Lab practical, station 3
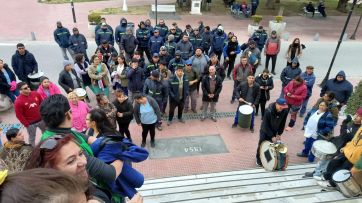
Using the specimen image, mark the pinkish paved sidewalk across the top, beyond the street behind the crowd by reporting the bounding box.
[0,0,362,42]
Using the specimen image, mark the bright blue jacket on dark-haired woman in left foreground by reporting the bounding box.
[90,135,148,199]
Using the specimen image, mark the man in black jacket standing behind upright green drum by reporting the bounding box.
[232,74,260,133]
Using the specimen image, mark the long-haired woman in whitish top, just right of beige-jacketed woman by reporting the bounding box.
[111,54,129,95]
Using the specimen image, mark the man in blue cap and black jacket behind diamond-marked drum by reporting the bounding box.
[256,98,288,166]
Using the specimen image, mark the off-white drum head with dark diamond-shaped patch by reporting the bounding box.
[260,141,276,171]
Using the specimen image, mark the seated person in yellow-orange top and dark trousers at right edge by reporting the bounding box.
[317,127,362,187]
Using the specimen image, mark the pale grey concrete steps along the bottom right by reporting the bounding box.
[139,164,362,203]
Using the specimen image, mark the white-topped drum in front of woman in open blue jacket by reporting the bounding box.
[311,140,337,160]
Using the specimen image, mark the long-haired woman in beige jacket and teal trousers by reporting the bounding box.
[88,55,110,97]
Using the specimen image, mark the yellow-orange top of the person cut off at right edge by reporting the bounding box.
[343,127,362,164]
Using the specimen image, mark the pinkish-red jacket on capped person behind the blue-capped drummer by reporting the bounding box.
[283,80,307,106]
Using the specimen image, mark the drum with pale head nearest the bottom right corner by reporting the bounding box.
[332,169,362,197]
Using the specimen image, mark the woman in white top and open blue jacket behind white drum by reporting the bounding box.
[297,101,335,162]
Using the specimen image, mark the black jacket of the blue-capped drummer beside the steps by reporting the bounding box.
[260,102,288,139]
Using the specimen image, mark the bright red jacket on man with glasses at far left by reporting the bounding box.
[14,91,43,127]
